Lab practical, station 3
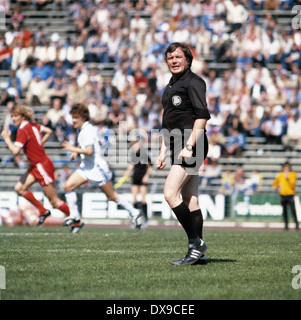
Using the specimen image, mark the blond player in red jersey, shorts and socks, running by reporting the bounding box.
[1,105,70,226]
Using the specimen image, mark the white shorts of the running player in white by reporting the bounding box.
[77,161,112,187]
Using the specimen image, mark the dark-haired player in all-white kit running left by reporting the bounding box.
[63,104,143,233]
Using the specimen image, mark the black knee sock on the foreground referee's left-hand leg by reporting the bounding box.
[172,202,200,245]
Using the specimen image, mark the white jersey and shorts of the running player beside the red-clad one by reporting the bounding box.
[77,121,112,186]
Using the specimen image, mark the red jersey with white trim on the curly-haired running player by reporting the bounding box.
[15,121,48,166]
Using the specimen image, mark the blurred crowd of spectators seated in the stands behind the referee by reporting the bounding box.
[0,0,301,168]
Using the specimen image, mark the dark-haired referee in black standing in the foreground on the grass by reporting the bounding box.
[156,42,210,265]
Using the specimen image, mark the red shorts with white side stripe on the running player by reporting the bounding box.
[28,158,55,187]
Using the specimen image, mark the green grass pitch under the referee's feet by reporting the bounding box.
[0,227,301,300]
